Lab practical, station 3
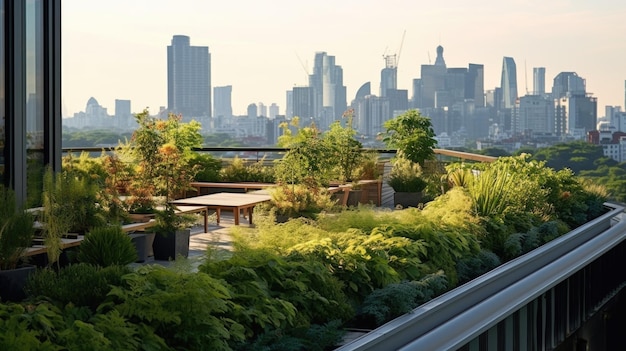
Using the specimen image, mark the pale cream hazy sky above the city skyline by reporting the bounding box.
[61,0,626,117]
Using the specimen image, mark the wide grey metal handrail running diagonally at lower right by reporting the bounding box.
[336,203,626,351]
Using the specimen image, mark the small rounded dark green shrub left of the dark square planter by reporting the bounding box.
[77,226,137,267]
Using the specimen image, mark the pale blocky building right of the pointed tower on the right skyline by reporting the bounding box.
[511,95,555,136]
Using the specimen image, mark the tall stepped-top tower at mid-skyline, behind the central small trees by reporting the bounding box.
[309,52,348,130]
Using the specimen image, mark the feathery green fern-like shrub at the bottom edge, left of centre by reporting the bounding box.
[99,265,243,350]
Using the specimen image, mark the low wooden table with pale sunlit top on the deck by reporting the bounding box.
[171,193,270,225]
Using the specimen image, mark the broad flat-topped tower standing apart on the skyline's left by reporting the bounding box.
[167,35,212,119]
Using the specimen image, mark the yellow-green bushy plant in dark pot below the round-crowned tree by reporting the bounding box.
[387,155,428,208]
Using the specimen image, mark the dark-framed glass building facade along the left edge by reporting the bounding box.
[0,0,62,206]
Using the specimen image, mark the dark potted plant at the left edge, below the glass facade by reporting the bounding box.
[0,185,36,301]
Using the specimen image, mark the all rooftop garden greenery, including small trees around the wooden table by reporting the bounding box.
[0,111,608,350]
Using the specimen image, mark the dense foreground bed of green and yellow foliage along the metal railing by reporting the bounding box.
[0,150,606,351]
